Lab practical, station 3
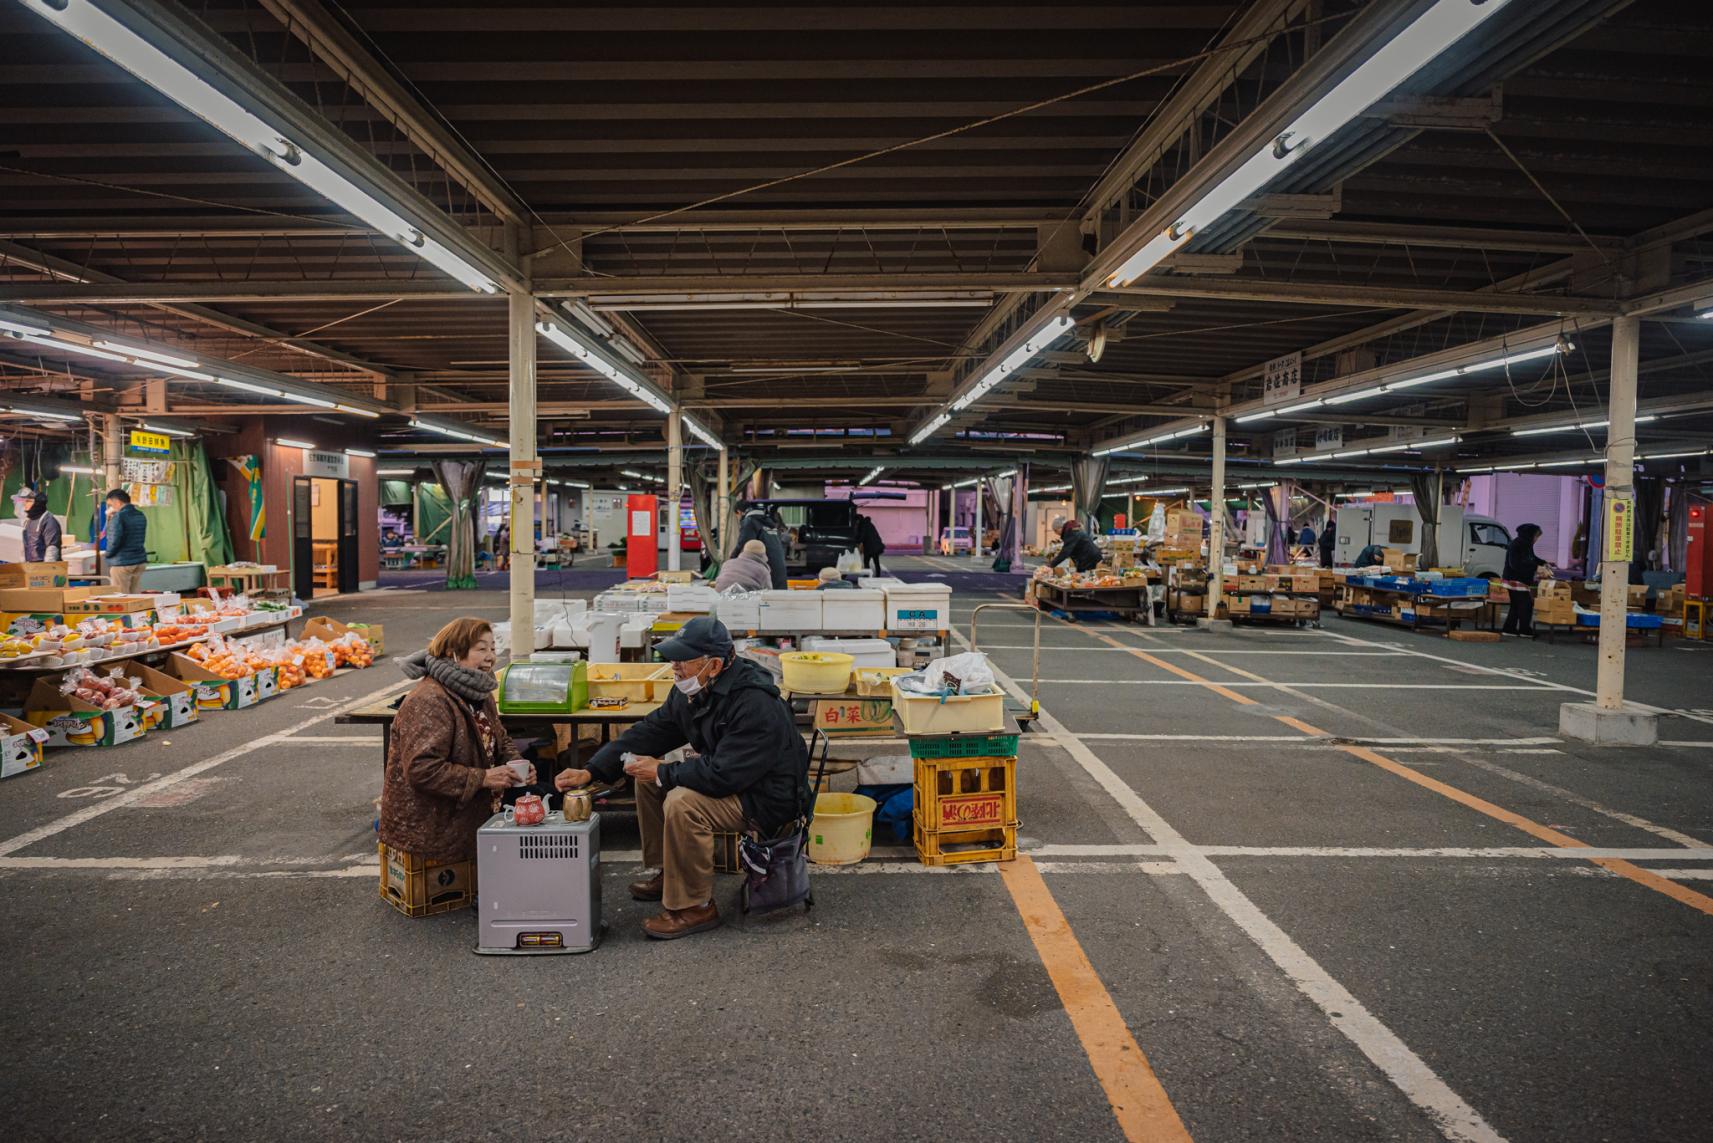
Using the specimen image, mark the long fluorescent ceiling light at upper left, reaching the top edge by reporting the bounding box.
[26,0,498,293]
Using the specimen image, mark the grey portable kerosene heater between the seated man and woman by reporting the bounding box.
[476,811,606,956]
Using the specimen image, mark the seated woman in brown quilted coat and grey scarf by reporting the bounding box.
[380,619,534,862]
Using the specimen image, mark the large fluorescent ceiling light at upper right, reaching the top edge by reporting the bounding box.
[1107,0,1507,286]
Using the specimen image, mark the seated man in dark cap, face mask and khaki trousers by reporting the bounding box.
[555,617,809,941]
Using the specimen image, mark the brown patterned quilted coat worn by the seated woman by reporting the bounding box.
[380,679,517,862]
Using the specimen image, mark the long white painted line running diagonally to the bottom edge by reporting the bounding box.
[954,632,1504,1143]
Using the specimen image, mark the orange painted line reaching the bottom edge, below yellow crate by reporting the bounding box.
[999,855,1191,1143]
